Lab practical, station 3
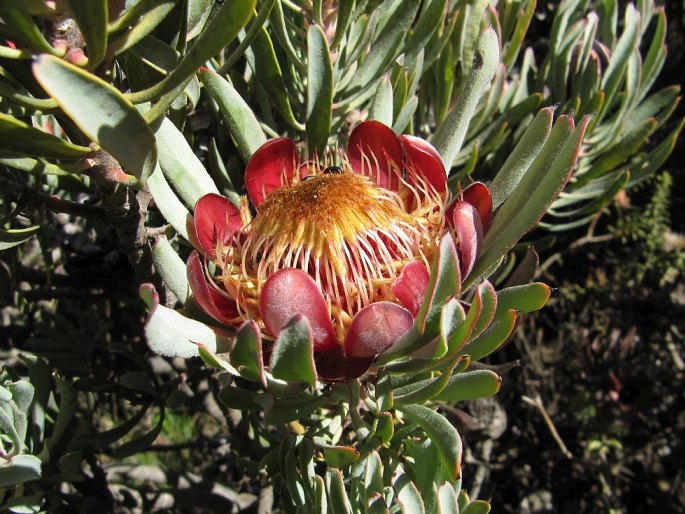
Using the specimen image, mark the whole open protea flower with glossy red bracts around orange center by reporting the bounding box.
[188,121,491,380]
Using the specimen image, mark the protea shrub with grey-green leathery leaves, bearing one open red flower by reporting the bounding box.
[0,0,677,513]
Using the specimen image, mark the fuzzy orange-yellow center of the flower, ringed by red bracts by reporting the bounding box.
[222,169,442,340]
